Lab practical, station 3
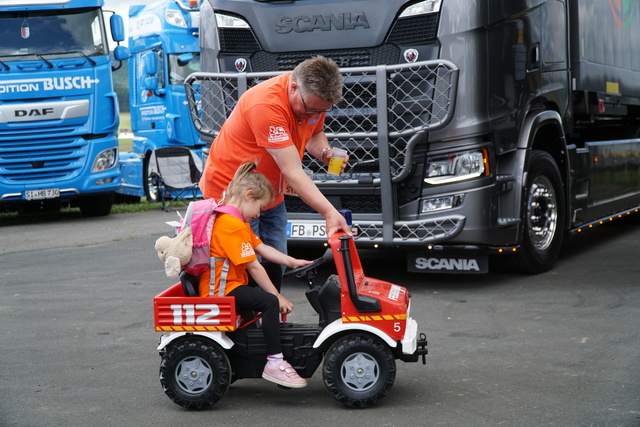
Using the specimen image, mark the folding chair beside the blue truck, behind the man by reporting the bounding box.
[149,146,202,211]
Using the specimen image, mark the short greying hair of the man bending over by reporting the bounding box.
[292,56,342,104]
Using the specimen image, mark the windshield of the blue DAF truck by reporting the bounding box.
[0,8,107,61]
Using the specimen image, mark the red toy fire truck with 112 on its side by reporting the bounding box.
[154,232,427,409]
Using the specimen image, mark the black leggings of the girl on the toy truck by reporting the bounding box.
[227,286,282,356]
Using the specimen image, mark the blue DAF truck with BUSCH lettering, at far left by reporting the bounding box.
[0,0,128,216]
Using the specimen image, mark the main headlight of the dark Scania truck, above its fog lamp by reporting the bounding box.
[424,148,489,184]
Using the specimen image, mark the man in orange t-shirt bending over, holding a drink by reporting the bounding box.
[200,56,351,253]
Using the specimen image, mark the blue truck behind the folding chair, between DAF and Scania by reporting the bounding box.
[119,0,204,201]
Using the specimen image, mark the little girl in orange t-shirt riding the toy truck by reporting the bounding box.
[198,162,311,388]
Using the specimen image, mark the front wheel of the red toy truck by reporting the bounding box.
[322,334,396,408]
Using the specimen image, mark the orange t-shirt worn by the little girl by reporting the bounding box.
[198,212,262,297]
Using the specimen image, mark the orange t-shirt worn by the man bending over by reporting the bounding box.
[200,73,325,209]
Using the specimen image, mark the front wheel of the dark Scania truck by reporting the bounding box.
[517,150,565,274]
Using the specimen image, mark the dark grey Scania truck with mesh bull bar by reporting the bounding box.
[187,0,640,273]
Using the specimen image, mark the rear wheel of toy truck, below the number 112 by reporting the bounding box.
[160,338,231,409]
